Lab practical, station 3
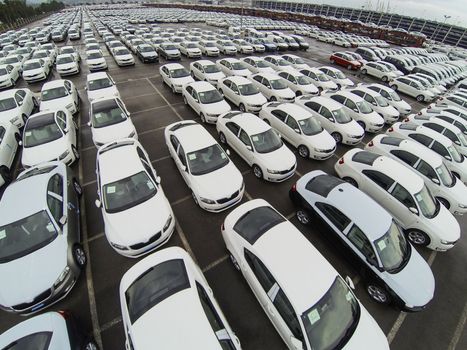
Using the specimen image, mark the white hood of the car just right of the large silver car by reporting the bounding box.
[102,188,173,246]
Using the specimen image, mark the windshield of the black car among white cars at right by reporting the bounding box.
[374,221,410,272]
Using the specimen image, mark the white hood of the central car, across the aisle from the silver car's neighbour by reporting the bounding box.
[192,161,243,200]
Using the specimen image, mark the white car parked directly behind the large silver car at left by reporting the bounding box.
[21,109,79,168]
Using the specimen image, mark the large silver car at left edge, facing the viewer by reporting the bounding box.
[0,161,86,314]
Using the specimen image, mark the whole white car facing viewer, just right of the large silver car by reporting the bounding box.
[96,138,175,258]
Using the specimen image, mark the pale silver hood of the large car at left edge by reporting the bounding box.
[0,234,68,306]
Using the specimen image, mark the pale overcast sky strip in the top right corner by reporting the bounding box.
[282,0,467,27]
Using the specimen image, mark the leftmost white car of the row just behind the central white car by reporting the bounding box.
[182,81,232,124]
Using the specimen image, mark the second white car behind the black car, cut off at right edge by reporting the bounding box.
[365,134,467,215]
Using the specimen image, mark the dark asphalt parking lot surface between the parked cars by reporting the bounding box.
[0,19,467,350]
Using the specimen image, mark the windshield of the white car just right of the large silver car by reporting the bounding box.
[103,171,157,213]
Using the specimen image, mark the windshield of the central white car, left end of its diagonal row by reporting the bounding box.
[187,143,229,176]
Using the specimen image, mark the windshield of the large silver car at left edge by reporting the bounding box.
[0,210,57,263]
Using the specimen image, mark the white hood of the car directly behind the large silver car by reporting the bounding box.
[21,136,67,166]
